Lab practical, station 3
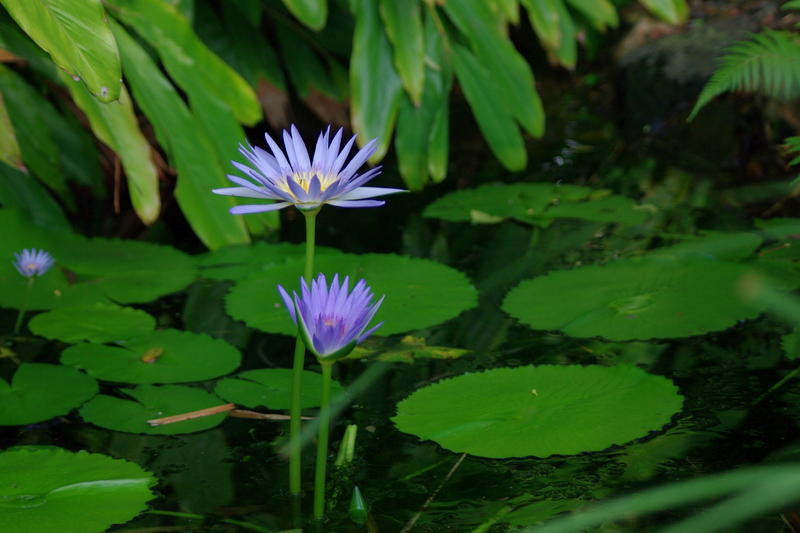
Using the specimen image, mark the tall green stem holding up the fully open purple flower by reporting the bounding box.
[289,210,319,494]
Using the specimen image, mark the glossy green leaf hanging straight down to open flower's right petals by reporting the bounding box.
[350,0,403,163]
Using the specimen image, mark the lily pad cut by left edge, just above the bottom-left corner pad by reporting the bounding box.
[0,363,98,424]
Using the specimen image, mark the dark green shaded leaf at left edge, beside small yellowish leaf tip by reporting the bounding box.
[0,65,65,200]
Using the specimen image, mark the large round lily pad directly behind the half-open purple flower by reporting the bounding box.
[226,254,477,335]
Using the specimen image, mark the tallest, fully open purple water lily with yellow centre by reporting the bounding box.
[214,126,405,215]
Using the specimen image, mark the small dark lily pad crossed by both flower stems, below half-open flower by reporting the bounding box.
[214,368,344,409]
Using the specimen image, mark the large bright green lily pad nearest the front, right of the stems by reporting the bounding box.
[392,365,683,458]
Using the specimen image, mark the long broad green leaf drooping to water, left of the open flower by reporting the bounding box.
[112,18,249,249]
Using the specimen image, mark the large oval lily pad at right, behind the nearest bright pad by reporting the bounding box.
[503,256,759,340]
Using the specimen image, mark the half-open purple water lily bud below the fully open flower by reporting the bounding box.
[278,274,384,361]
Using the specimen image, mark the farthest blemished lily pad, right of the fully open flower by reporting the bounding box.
[423,183,647,227]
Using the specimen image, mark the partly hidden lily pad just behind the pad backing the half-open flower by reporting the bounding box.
[198,242,342,280]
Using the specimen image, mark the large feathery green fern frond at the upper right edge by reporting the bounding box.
[688,30,800,120]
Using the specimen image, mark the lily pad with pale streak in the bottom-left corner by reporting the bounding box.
[0,447,156,533]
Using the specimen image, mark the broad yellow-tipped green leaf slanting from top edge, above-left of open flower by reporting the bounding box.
[107,0,261,125]
